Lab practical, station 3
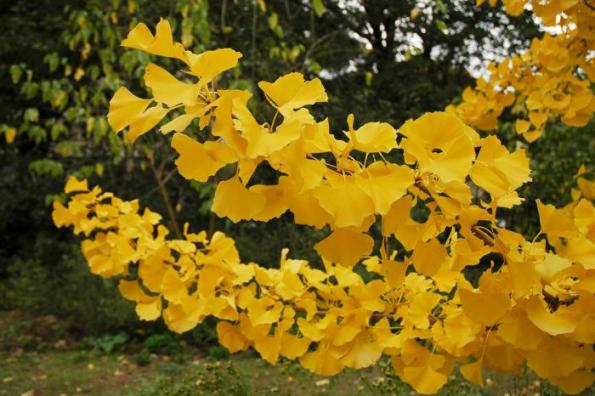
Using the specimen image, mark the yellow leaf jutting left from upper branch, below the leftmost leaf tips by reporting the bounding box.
[171,133,237,182]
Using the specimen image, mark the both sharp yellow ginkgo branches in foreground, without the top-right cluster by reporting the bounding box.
[53,3,595,394]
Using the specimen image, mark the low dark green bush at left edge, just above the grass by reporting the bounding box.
[0,243,139,335]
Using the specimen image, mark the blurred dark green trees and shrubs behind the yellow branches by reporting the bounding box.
[0,0,595,394]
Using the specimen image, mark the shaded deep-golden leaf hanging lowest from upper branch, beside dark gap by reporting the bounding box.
[314,229,374,267]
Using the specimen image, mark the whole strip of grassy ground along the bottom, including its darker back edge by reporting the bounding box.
[0,313,593,396]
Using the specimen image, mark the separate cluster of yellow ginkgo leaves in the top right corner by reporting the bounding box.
[450,0,595,142]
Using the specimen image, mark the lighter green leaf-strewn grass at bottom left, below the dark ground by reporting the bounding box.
[0,350,379,396]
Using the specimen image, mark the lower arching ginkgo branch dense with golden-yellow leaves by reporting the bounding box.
[53,169,595,394]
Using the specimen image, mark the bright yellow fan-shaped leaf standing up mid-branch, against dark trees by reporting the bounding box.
[258,73,328,115]
